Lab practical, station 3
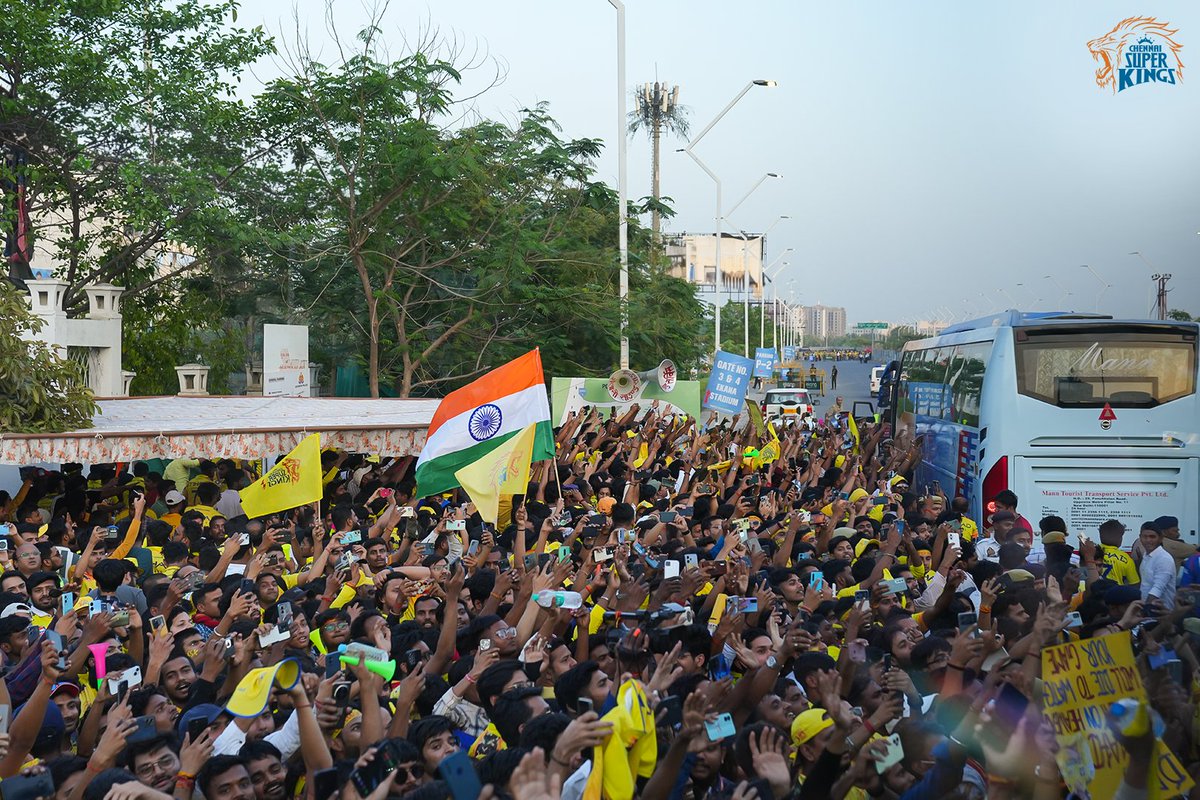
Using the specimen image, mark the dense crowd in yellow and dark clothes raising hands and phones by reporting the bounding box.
[0,404,1200,800]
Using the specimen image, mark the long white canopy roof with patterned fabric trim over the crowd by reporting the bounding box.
[0,397,440,464]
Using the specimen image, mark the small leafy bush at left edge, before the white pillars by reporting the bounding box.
[0,281,96,433]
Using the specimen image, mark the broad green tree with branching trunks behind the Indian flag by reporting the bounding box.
[259,26,700,397]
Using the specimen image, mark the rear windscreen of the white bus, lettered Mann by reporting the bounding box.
[1015,326,1196,408]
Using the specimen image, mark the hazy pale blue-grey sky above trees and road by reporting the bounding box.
[248,0,1200,321]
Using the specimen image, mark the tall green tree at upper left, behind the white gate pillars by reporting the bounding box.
[0,0,272,390]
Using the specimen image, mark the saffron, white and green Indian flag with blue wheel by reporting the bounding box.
[416,350,554,497]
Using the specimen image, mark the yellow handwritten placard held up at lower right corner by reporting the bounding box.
[1042,631,1193,800]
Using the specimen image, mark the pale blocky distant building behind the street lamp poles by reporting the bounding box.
[662,233,763,300]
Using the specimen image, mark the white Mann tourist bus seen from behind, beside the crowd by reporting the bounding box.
[892,311,1200,547]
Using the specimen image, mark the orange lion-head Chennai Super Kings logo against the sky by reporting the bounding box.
[1087,17,1183,94]
